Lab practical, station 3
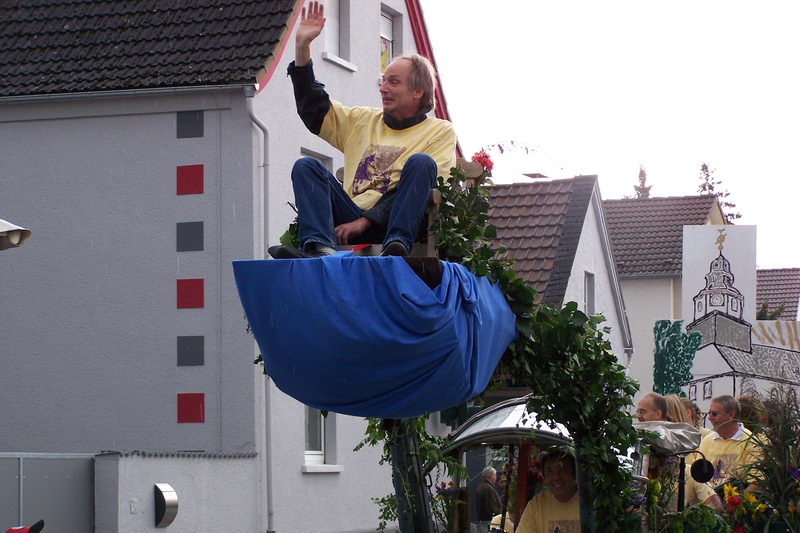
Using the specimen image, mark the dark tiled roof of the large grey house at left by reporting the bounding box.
[0,0,296,96]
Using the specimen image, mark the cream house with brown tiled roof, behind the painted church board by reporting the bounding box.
[603,195,725,400]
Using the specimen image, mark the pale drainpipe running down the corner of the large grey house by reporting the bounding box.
[244,86,275,533]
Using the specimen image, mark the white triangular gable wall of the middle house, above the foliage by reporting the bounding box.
[564,193,635,365]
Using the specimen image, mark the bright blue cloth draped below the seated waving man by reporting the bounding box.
[233,252,516,418]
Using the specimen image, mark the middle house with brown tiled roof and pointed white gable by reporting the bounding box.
[489,176,634,365]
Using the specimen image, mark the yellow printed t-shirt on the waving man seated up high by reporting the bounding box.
[319,100,456,210]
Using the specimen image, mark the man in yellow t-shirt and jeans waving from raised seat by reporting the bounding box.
[269,1,456,259]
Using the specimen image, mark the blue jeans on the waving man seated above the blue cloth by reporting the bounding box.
[292,154,437,250]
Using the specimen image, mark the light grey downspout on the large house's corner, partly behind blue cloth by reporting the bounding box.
[244,87,275,533]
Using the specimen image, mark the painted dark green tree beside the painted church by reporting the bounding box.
[653,320,703,395]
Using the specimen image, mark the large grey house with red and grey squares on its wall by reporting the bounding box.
[0,0,447,533]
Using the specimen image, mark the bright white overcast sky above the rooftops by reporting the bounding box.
[422,0,800,268]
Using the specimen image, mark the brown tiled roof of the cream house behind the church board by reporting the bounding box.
[603,195,716,278]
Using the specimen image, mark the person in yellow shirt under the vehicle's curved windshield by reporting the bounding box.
[517,450,581,533]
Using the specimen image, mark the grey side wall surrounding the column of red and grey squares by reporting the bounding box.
[0,91,255,452]
